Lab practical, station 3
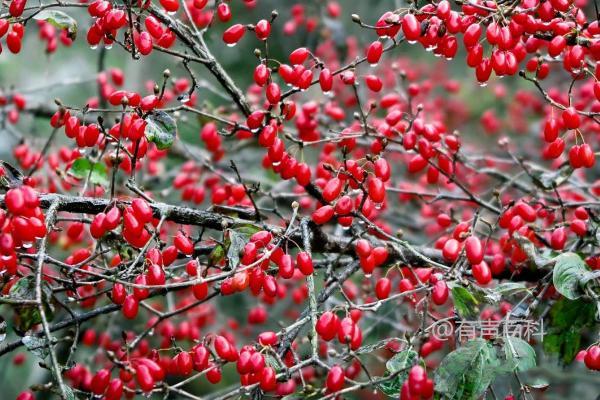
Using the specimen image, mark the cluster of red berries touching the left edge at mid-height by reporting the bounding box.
[0,185,46,275]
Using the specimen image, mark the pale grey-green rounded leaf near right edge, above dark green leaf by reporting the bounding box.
[552,253,589,300]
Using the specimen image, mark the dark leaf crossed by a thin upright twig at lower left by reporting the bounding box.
[9,276,54,332]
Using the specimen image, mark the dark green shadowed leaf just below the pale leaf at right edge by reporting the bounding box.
[544,297,596,364]
